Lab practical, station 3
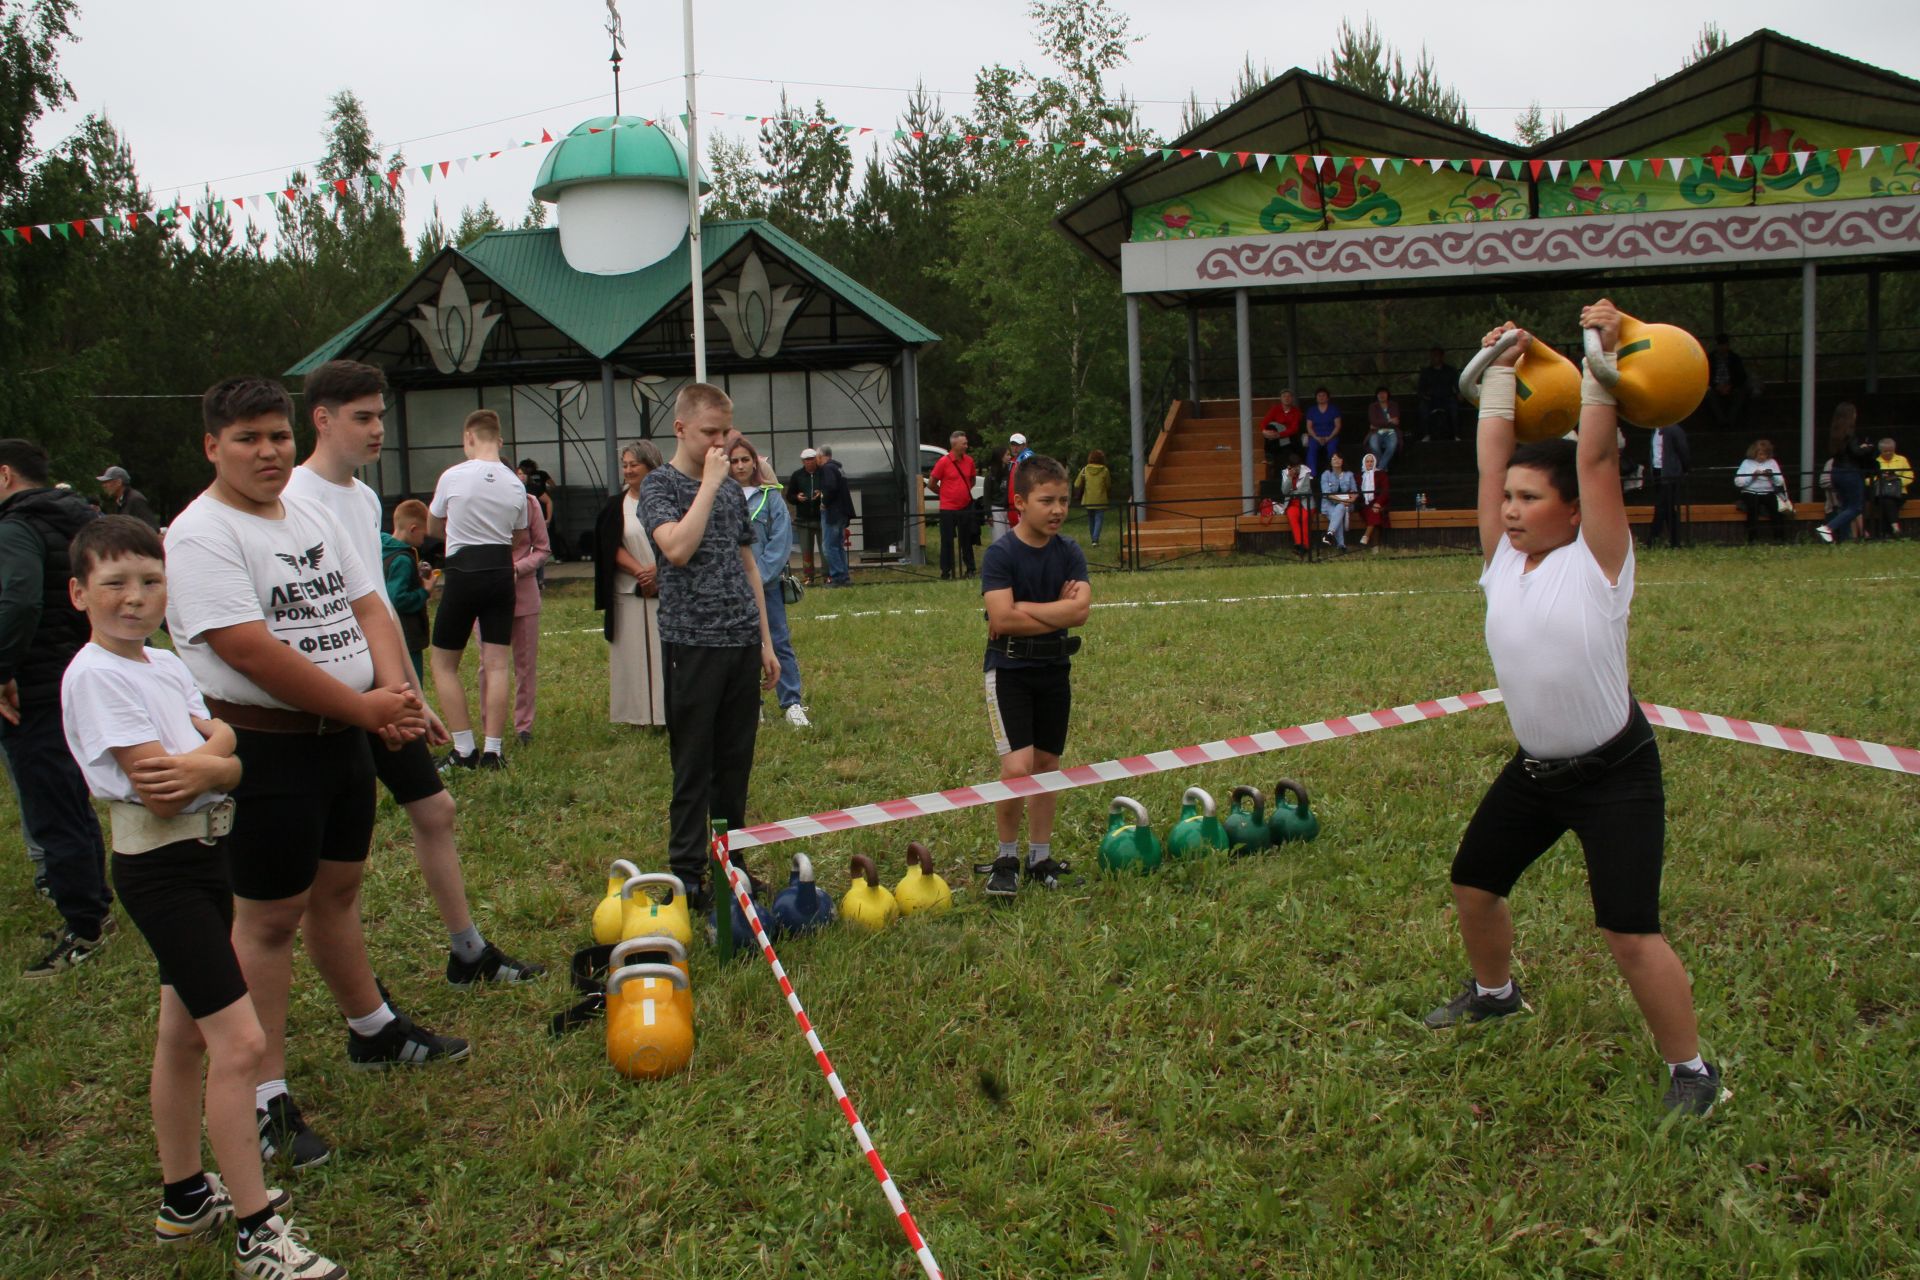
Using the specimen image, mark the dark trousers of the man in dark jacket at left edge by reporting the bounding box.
[0,697,113,938]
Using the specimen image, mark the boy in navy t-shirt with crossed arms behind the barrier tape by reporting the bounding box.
[979,455,1092,898]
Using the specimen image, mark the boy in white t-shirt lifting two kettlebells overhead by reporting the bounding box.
[1427,299,1720,1115]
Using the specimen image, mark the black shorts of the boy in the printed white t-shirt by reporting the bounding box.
[227,729,384,902]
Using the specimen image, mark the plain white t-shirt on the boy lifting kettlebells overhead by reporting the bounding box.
[1480,535,1634,760]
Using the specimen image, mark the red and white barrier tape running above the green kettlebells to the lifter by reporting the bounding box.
[732,689,1500,848]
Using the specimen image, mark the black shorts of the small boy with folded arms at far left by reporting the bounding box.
[113,841,246,1017]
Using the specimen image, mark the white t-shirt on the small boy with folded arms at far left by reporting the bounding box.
[60,645,227,814]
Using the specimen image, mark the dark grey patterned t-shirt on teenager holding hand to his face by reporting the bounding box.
[639,462,760,649]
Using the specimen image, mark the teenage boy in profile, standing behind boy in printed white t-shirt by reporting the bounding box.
[286,361,545,986]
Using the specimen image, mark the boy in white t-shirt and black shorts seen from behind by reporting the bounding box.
[426,409,526,770]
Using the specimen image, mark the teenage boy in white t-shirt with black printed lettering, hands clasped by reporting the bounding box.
[167,378,467,1169]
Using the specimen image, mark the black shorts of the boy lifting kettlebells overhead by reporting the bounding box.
[1453,704,1667,933]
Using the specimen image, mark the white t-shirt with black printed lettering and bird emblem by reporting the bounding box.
[167,493,384,710]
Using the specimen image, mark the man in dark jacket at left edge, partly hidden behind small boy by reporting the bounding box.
[0,439,113,979]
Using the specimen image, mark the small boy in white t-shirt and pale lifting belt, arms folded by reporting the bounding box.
[61,516,346,1280]
